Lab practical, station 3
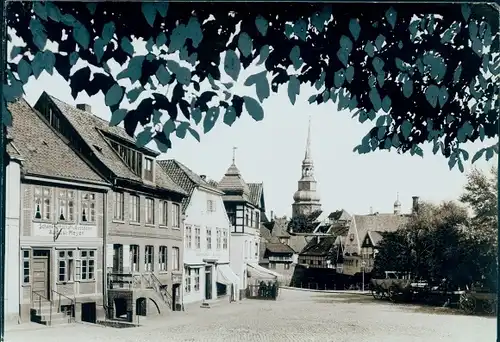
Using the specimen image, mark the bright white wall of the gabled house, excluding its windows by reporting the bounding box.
[183,188,231,304]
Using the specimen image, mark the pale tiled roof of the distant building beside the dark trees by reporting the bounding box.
[345,214,408,254]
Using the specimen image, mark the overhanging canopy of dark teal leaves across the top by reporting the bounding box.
[4,2,500,170]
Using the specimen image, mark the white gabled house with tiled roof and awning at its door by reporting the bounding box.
[159,160,240,304]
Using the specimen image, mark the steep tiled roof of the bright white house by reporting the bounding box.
[157,159,219,212]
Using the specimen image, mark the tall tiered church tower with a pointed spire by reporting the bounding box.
[292,117,321,217]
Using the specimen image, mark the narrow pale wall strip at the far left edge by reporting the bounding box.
[4,160,21,324]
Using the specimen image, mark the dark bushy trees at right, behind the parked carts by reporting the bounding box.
[374,202,497,288]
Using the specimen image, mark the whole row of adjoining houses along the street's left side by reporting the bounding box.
[4,93,280,324]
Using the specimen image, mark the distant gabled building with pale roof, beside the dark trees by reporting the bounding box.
[343,197,412,275]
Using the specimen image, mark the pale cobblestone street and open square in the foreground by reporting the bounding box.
[6,290,496,342]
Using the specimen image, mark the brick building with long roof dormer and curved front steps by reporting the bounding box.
[35,93,186,321]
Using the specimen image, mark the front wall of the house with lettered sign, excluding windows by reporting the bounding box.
[17,181,104,321]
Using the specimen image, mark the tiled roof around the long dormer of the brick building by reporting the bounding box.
[39,93,186,195]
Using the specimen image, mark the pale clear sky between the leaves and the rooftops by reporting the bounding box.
[8,31,497,216]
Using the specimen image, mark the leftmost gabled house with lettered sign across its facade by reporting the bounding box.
[5,99,111,325]
